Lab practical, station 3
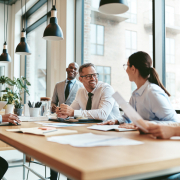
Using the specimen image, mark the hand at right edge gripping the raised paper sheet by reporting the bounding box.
[148,124,176,139]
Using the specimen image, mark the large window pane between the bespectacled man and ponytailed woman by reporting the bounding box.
[82,0,153,101]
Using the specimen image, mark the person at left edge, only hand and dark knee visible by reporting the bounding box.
[0,114,20,179]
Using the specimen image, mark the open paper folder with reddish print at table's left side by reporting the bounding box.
[6,127,77,136]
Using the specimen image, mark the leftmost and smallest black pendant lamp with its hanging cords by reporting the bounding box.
[0,0,11,63]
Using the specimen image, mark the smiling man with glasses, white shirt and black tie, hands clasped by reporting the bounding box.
[56,63,121,121]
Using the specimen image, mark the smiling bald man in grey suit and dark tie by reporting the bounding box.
[51,62,83,112]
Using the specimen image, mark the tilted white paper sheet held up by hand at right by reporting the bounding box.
[112,92,148,133]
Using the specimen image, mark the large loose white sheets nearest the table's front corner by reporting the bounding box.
[47,133,143,147]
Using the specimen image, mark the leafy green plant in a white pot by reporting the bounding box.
[0,76,31,114]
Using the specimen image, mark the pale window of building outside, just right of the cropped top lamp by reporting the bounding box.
[126,0,137,24]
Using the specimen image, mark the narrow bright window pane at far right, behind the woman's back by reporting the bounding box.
[165,0,180,110]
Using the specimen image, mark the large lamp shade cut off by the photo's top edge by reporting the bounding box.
[99,0,129,14]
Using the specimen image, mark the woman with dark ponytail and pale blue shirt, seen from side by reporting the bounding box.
[100,51,178,128]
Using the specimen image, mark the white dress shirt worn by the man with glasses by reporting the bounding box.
[71,81,121,121]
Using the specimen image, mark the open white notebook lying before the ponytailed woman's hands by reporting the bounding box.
[87,125,135,131]
